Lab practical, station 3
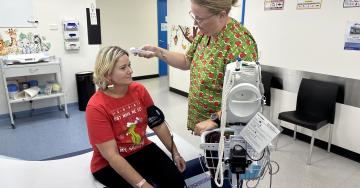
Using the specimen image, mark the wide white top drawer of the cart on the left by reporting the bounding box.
[4,64,60,77]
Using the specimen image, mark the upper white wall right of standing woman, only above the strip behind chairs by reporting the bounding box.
[245,0,360,79]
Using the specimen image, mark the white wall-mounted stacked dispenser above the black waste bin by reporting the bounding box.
[63,20,80,50]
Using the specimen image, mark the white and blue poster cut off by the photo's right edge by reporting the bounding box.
[344,21,360,50]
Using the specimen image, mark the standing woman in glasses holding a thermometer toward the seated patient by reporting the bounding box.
[139,0,258,135]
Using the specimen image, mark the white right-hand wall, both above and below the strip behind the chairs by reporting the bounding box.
[245,1,360,153]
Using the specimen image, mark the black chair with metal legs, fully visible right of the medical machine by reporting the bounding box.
[278,78,339,165]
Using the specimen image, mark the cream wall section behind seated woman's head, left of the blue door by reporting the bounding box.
[97,0,159,76]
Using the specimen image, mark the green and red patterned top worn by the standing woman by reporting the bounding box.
[186,19,258,130]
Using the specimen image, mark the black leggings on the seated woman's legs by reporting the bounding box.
[93,143,185,188]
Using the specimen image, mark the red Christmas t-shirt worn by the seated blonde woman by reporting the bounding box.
[86,82,153,173]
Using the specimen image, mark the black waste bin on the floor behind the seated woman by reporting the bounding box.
[75,71,95,111]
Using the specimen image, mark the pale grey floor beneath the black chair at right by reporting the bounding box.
[253,135,360,188]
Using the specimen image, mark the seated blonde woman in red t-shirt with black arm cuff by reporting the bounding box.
[86,46,186,188]
